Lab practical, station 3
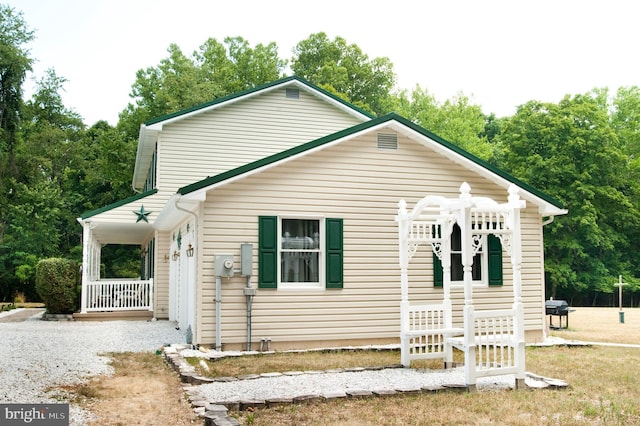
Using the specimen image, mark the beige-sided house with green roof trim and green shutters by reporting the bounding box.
[78,77,566,349]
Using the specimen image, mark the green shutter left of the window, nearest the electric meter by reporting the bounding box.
[258,216,278,288]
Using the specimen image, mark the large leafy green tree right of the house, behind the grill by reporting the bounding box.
[498,92,640,298]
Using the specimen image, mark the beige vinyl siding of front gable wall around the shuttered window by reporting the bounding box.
[200,130,542,349]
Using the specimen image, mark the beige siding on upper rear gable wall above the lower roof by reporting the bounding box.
[157,88,361,191]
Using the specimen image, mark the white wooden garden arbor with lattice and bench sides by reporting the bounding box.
[396,182,526,390]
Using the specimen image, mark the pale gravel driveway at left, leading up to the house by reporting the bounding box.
[0,311,185,424]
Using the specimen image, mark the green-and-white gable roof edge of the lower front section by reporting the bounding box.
[177,113,567,216]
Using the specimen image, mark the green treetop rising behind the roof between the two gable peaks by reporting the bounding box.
[291,32,396,115]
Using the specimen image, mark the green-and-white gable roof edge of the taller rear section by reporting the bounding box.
[132,76,373,189]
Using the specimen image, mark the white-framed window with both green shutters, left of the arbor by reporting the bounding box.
[258,216,343,289]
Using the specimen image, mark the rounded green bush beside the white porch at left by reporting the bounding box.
[36,258,78,314]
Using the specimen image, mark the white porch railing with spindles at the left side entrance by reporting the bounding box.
[83,278,153,312]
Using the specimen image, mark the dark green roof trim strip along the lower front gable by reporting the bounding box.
[178,113,564,209]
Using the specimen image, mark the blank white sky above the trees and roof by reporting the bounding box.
[5,0,640,125]
